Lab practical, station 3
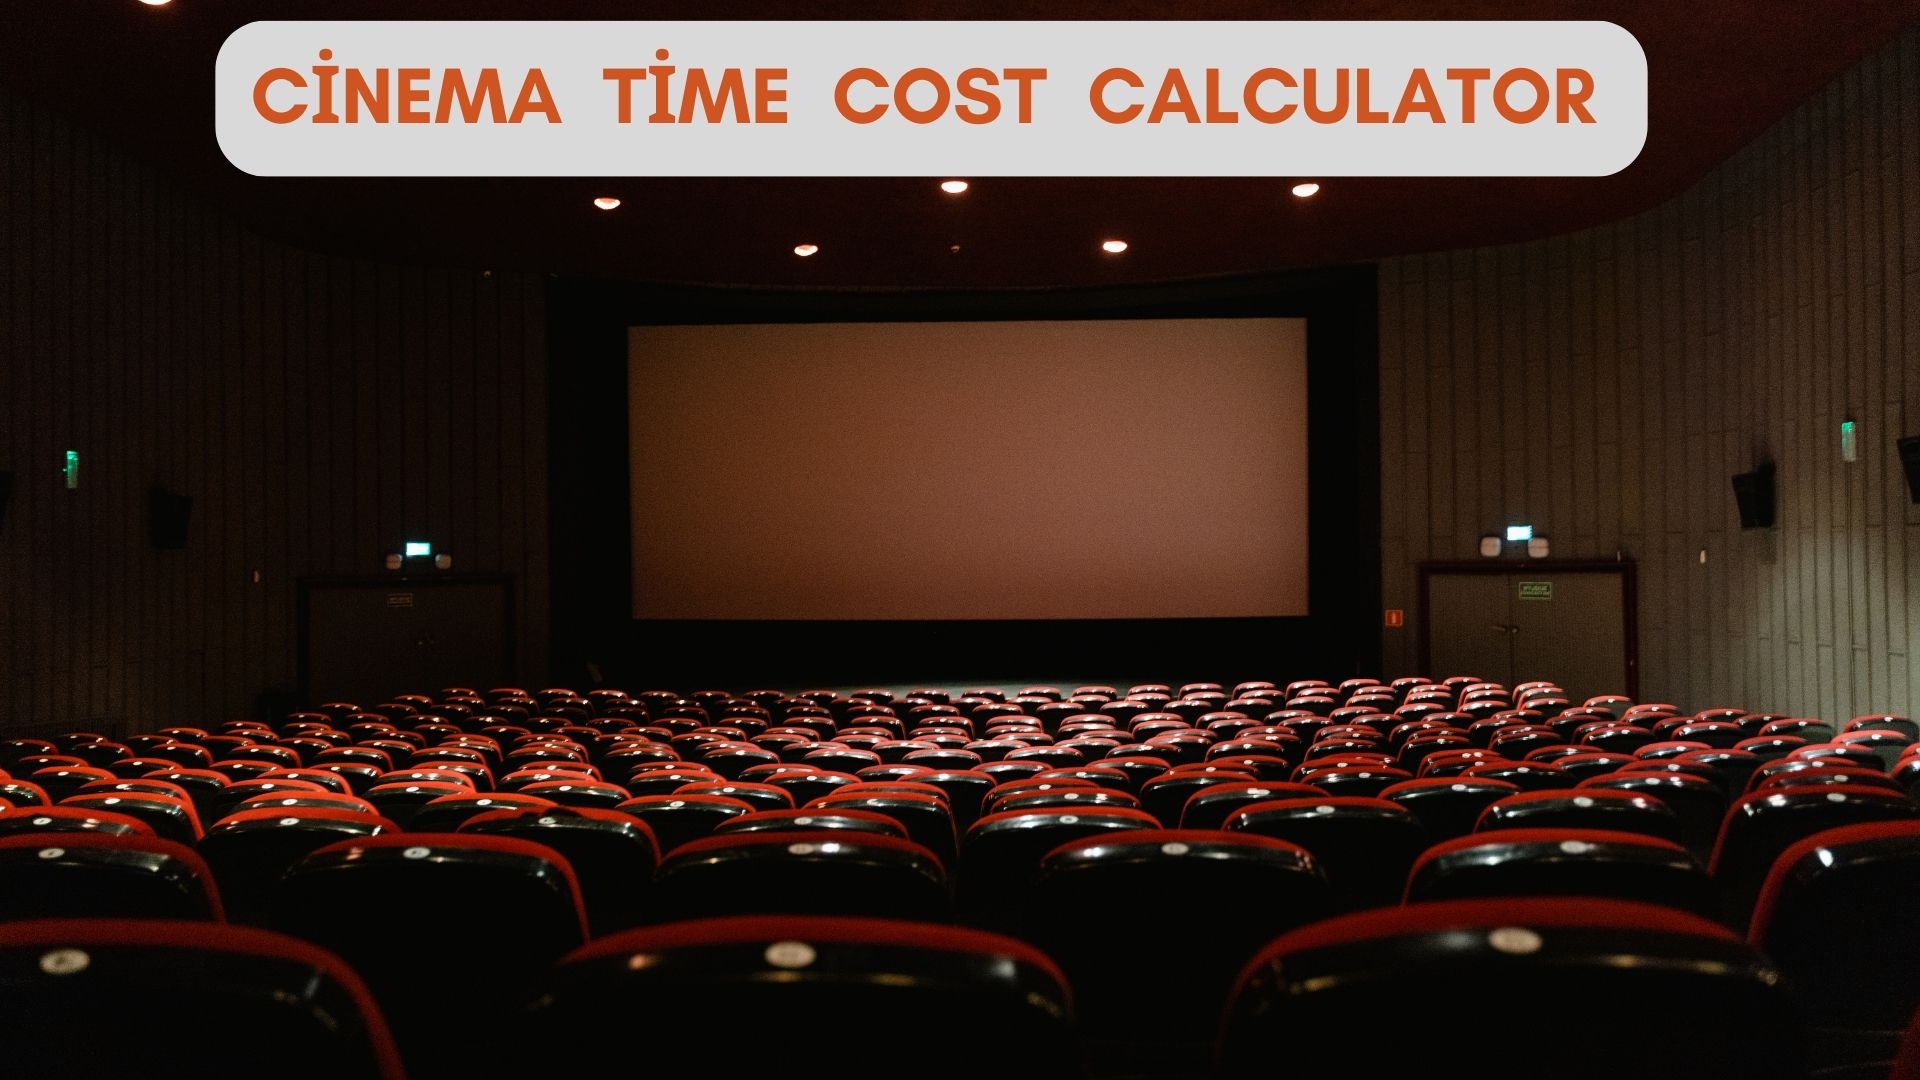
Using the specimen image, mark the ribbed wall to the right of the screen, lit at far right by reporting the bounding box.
[1379,29,1920,719]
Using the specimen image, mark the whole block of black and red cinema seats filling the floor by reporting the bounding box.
[0,678,1920,1078]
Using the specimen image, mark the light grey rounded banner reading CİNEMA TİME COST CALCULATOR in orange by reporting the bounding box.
[215,21,1647,177]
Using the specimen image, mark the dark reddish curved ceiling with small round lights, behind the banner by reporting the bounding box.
[0,0,1920,288]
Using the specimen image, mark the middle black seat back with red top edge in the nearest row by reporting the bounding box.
[516,917,1077,1076]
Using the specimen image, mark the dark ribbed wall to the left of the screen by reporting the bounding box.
[0,94,547,730]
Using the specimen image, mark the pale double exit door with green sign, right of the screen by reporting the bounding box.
[1421,561,1640,703]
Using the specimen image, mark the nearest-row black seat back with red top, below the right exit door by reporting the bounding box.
[1217,897,1805,1080]
